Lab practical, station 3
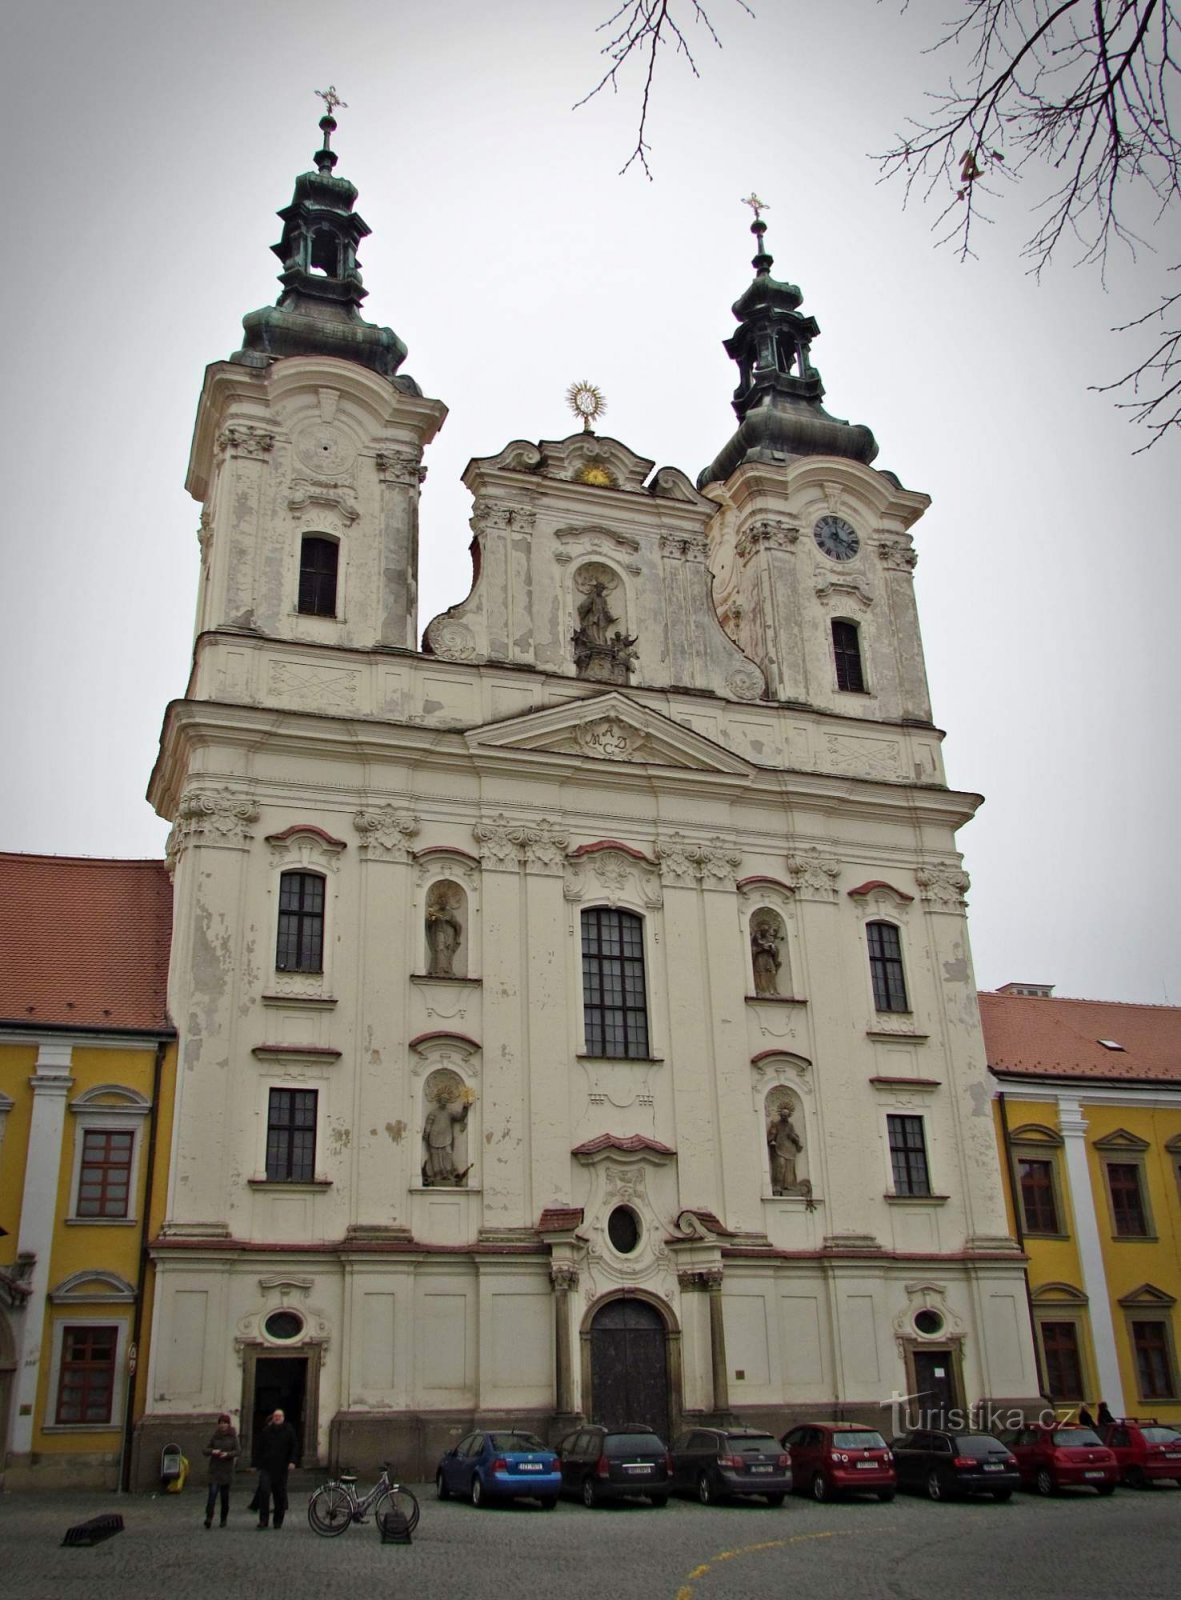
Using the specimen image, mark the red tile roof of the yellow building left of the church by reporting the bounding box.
[0,851,173,1032]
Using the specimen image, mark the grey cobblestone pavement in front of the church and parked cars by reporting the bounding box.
[0,1485,1181,1600]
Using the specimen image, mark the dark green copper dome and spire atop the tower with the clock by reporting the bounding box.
[698,218,877,490]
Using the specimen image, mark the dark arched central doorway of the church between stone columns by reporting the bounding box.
[591,1296,671,1440]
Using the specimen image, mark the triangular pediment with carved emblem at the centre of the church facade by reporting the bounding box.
[466,693,754,778]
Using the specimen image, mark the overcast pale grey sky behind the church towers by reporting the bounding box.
[0,0,1181,1003]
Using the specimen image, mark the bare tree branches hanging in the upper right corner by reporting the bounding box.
[879,0,1181,448]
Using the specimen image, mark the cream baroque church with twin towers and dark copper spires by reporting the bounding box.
[139,117,1037,1482]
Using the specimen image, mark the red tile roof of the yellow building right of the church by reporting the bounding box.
[979,994,1181,1083]
